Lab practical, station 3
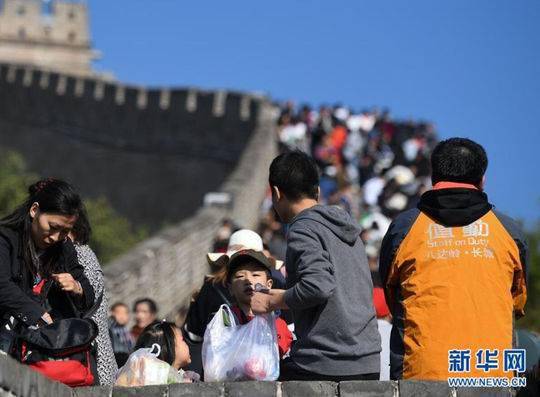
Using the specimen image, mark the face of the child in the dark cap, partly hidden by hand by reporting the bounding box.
[230,262,272,305]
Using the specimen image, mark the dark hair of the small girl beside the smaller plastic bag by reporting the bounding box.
[135,321,176,365]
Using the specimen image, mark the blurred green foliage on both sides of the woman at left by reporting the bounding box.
[0,149,148,263]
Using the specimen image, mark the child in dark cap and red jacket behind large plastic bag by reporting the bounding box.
[227,250,293,358]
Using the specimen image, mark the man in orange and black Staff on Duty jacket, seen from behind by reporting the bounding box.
[379,138,527,381]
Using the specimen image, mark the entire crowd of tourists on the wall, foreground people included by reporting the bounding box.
[0,104,537,392]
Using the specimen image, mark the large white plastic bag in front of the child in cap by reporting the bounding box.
[202,305,279,382]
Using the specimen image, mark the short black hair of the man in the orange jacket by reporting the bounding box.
[431,138,488,185]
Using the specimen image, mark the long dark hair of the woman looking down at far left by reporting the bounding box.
[0,178,84,277]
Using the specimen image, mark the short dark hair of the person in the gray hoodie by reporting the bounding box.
[268,150,319,201]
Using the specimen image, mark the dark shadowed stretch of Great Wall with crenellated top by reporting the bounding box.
[0,63,271,231]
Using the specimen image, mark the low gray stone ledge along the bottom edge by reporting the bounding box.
[0,355,520,397]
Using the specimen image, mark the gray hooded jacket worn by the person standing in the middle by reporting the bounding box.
[285,205,381,376]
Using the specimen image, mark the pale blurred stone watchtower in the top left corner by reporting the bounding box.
[0,0,105,77]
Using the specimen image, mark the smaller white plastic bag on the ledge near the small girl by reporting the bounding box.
[116,344,184,387]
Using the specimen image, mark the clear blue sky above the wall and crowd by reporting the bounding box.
[88,0,540,224]
